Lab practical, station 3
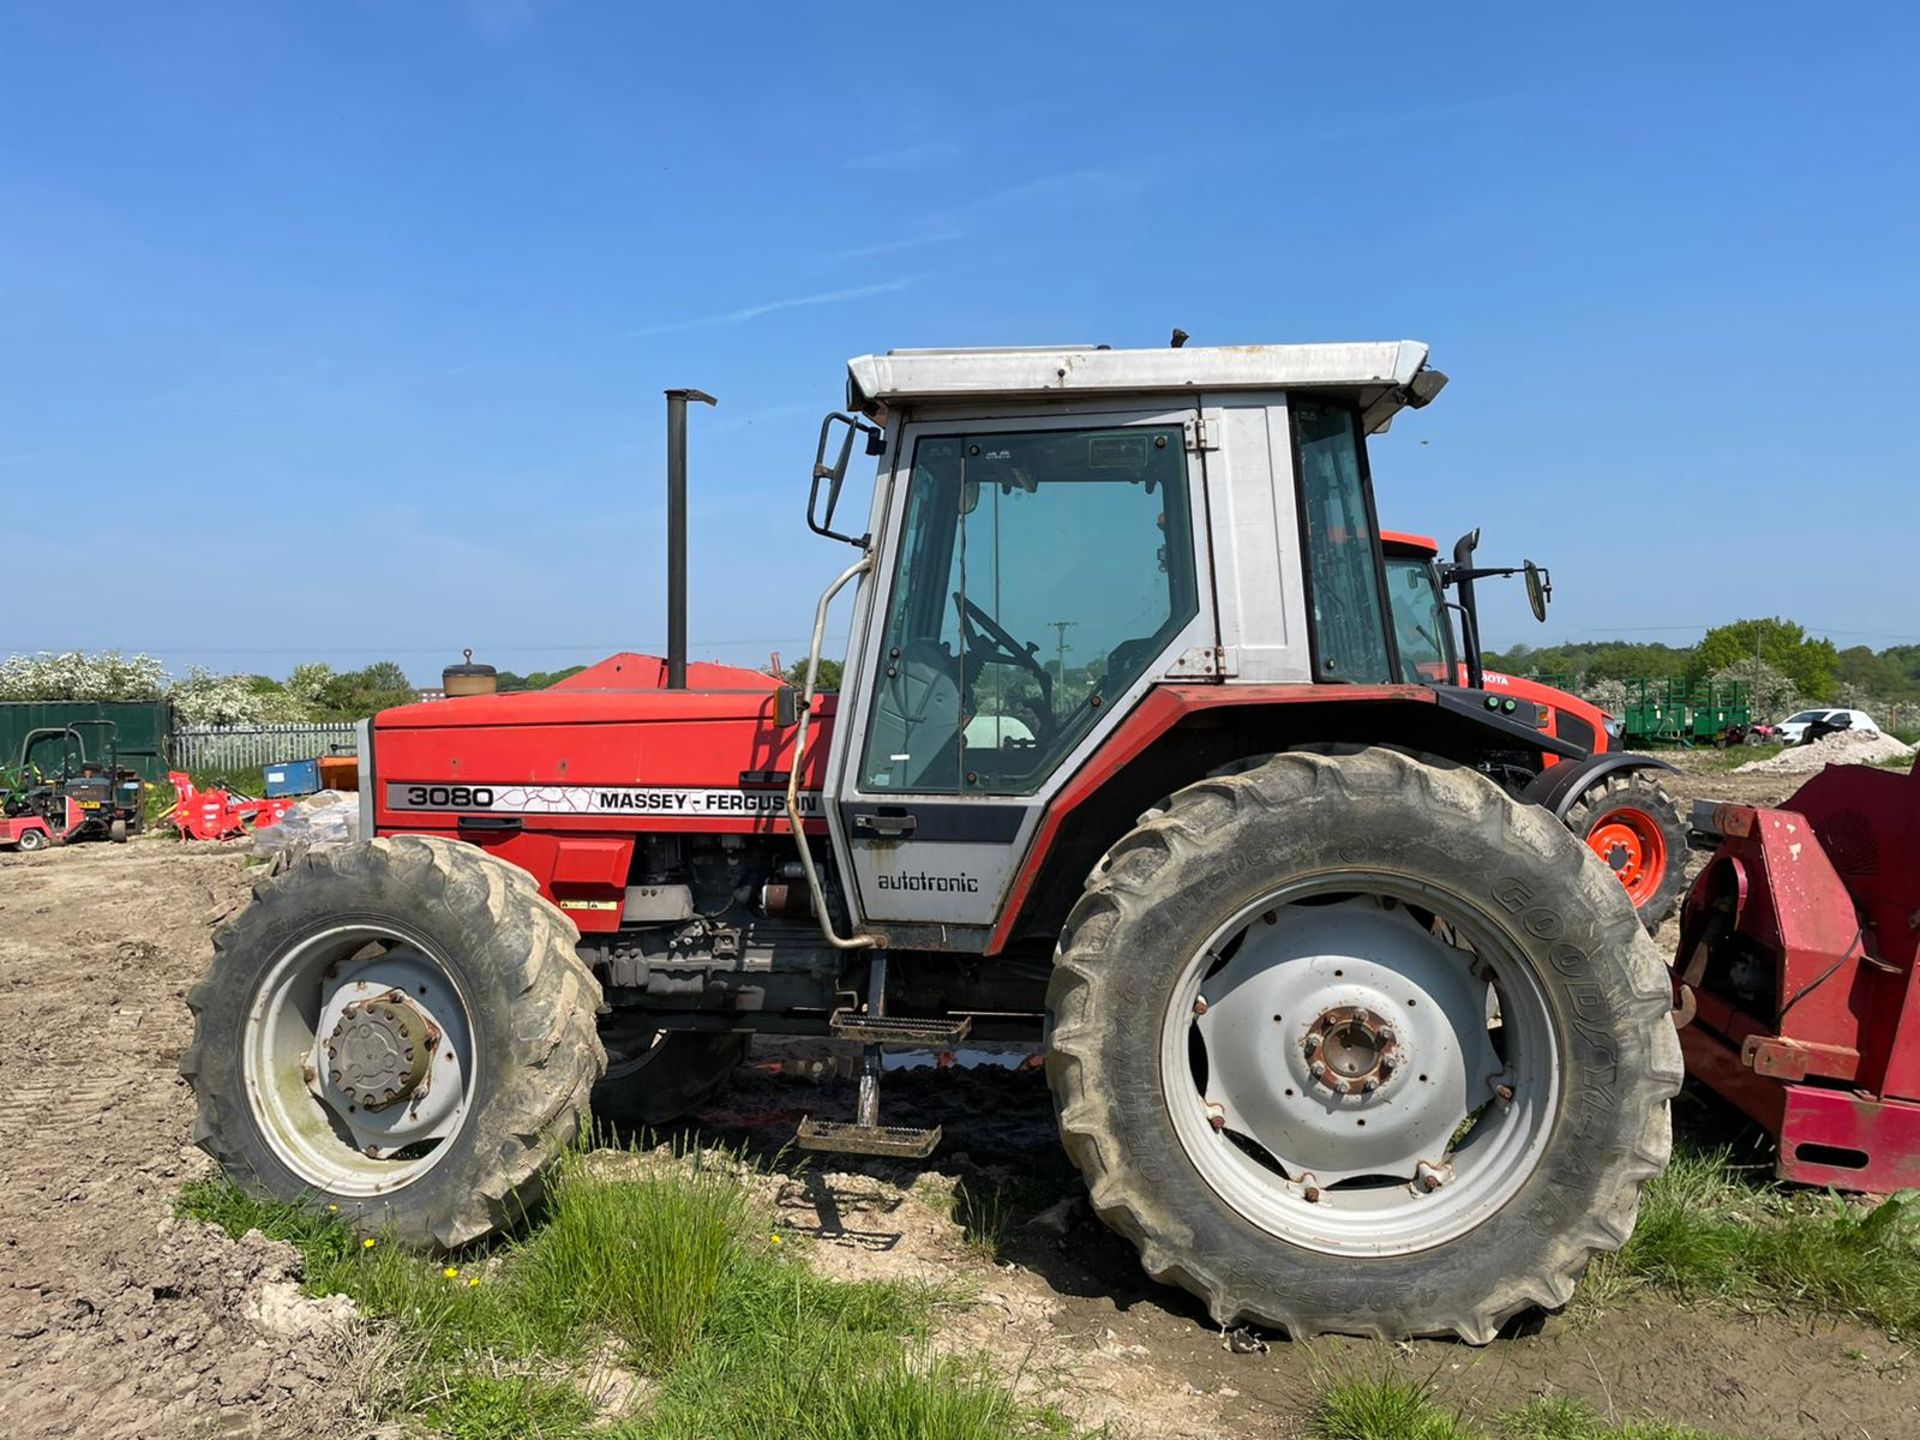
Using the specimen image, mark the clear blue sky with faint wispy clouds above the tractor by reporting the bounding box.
[0,0,1920,680]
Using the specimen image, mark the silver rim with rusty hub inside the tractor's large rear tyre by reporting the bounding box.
[1160,874,1559,1256]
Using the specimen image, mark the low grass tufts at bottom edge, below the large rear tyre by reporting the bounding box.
[1306,1375,1732,1440]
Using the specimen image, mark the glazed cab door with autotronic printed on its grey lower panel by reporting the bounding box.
[833,409,1215,948]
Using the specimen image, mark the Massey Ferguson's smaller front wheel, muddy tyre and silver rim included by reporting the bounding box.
[180,835,605,1248]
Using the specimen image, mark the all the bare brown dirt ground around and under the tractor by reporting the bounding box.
[0,756,1920,1440]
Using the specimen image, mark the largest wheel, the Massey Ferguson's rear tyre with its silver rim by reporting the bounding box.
[1046,749,1682,1344]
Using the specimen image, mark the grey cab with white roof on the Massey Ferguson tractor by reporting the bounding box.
[793,342,1582,950]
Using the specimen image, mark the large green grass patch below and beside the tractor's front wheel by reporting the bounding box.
[179,1152,1066,1440]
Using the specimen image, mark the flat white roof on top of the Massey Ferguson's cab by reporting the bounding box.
[847,340,1444,415]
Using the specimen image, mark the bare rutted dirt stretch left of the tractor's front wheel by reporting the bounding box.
[0,841,370,1440]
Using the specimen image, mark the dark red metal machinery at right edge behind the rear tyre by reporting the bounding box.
[1674,762,1920,1192]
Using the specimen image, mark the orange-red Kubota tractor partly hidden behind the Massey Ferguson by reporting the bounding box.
[1380,532,1690,931]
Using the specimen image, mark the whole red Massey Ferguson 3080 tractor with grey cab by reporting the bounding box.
[180,342,1680,1342]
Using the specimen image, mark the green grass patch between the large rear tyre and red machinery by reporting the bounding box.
[1580,1144,1920,1334]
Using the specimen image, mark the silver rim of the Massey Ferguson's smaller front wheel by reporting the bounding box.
[242,925,478,1198]
